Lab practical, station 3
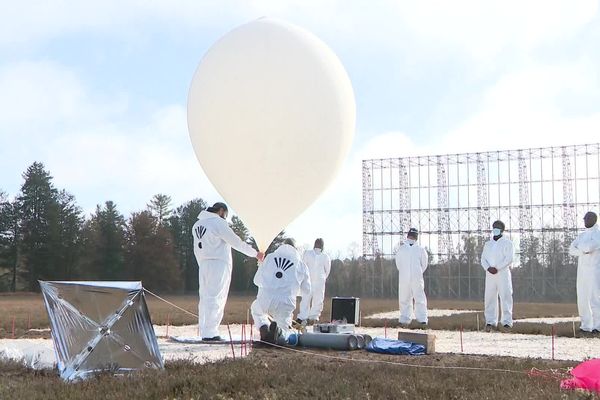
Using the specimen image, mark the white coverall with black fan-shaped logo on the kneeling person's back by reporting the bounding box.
[250,244,311,339]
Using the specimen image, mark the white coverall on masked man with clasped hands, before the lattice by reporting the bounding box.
[481,236,515,326]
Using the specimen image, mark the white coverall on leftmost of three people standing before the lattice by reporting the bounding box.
[396,241,427,324]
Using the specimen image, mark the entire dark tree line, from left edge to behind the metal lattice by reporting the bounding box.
[0,162,577,301]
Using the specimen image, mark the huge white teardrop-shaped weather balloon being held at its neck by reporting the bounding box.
[188,18,356,250]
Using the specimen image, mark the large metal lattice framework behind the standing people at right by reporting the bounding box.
[362,143,600,297]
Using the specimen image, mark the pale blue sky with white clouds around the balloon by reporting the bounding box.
[0,0,600,256]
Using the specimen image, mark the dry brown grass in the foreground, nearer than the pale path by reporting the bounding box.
[0,349,595,400]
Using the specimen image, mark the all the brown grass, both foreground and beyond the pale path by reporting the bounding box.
[0,294,597,400]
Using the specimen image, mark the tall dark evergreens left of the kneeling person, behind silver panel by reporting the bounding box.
[0,162,285,292]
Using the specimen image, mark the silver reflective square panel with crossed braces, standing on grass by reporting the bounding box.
[40,281,163,380]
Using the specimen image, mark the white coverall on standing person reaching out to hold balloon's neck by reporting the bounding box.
[192,210,257,338]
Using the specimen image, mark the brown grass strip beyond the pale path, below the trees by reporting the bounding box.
[0,293,579,338]
